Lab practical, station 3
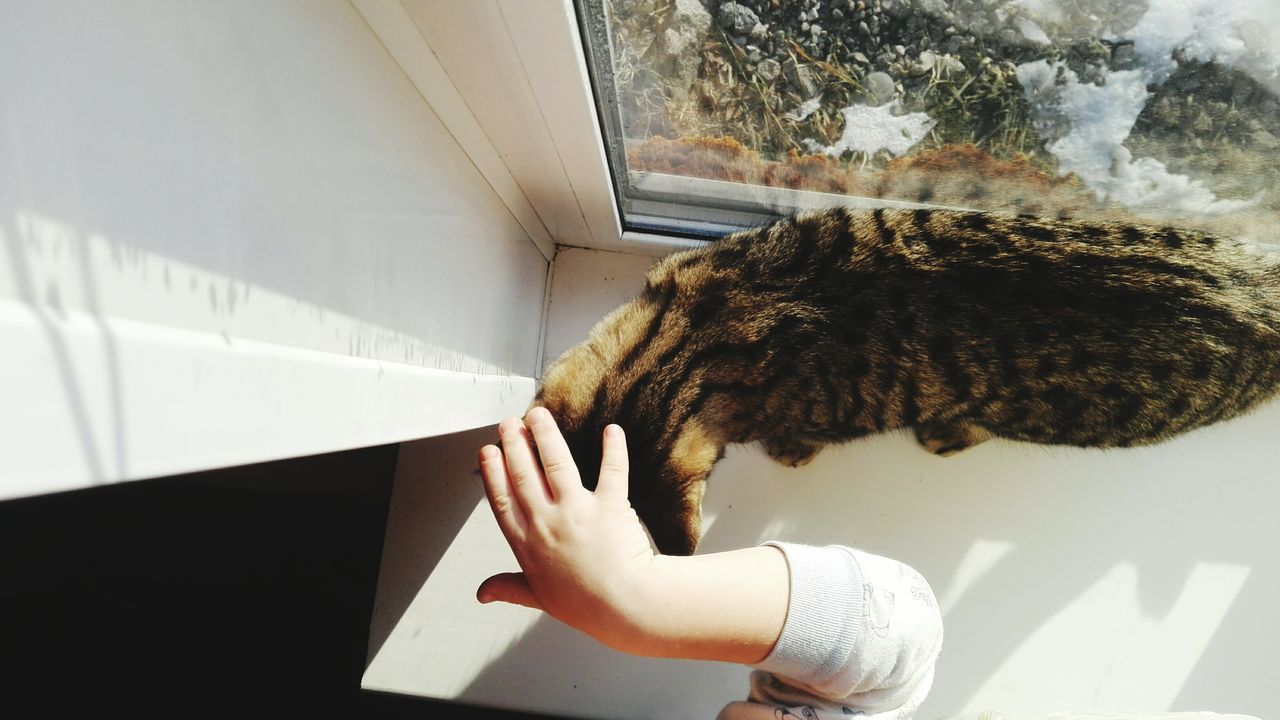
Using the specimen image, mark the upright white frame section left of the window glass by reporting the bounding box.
[373,0,622,247]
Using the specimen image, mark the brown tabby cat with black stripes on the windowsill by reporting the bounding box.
[535,209,1280,553]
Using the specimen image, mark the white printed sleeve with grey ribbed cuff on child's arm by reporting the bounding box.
[721,543,942,720]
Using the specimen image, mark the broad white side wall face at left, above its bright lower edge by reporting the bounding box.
[0,3,547,374]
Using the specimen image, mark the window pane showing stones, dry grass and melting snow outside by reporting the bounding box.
[581,0,1280,240]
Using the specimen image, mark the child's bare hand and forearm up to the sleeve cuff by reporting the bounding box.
[476,407,788,662]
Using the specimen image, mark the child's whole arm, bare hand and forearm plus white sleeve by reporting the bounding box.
[477,407,942,720]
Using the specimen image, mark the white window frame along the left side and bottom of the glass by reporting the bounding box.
[352,0,967,255]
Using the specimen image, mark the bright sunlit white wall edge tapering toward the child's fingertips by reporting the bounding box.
[0,301,534,500]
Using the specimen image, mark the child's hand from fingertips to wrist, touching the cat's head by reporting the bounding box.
[476,407,655,652]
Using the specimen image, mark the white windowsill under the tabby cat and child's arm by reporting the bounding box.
[365,244,1280,720]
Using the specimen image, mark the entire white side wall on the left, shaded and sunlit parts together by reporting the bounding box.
[0,0,547,496]
